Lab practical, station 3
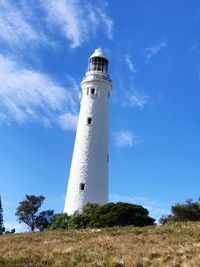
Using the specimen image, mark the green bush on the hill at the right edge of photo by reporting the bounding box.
[160,199,200,224]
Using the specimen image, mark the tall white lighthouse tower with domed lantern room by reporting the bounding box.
[64,48,112,214]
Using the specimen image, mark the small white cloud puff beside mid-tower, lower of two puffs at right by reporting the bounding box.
[115,130,139,148]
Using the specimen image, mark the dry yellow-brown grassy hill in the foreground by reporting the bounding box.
[0,222,200,267]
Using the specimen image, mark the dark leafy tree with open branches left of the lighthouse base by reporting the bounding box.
[15,195,53,231]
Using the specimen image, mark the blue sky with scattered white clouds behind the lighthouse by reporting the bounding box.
[0,0,200,231]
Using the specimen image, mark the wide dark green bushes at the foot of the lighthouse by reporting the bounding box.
[51,202,155,229]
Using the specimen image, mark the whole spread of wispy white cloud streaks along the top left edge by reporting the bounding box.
[0,0,113,48]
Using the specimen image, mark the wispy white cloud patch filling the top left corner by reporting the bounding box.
[0,0,44,47]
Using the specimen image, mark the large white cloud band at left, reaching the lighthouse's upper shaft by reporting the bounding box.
[0,54,77,130]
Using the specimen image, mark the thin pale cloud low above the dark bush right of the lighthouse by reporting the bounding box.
[109,194,170,221]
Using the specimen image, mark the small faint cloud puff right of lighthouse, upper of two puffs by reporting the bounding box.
[123,88,148,109]
